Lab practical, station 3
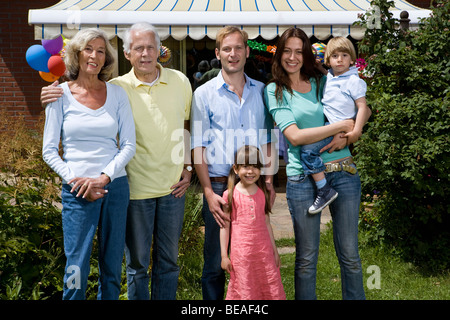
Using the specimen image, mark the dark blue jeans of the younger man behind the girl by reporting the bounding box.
[202,182,227,300]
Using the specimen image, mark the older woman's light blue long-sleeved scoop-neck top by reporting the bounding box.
[42,82,136,183]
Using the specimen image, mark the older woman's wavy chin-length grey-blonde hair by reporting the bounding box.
[64,28,115,81]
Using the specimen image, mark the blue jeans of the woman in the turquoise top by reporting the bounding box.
[286,165,365,300]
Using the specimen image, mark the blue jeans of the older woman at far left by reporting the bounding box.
[61,177,130,300]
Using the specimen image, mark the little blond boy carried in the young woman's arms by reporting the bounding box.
[300,37,371,214]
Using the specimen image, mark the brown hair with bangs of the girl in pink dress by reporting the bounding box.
[228,145,271,214]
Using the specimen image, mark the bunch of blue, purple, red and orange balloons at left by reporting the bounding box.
[26,35,66,82]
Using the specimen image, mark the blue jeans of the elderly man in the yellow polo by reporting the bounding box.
[125,194,185,300]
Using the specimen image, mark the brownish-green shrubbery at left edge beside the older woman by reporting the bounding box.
[0,114,64,300]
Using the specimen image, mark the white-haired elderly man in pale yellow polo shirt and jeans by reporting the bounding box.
[41,23,192,300]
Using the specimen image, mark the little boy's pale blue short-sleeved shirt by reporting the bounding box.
[322,67,367,123]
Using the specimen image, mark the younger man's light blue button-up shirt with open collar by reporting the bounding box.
[191,72,275,177]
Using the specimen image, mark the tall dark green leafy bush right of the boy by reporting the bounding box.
[355,0,450,268]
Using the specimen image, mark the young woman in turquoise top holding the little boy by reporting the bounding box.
[264,28,367,299]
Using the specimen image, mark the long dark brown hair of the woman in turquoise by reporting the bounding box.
[270,27,322,102]
